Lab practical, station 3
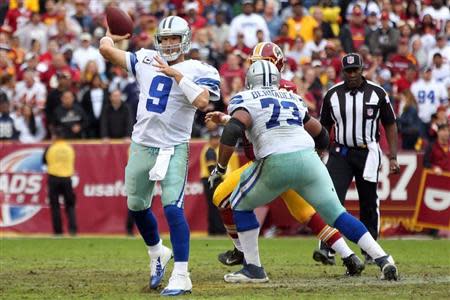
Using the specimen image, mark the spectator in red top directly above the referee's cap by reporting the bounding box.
[339,5,373,53]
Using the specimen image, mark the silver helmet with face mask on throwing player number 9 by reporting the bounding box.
[155,16,192,61]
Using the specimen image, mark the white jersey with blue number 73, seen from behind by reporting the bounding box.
[228,89,315,159]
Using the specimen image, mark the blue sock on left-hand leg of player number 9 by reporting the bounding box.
[129,208,159,246]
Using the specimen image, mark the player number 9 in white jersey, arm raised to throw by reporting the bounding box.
[100,16,220,296]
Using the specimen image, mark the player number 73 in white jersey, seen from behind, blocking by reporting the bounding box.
[210,60,398,283]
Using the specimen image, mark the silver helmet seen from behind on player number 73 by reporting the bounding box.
[245,60,281,89]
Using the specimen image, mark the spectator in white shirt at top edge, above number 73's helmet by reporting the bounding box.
[228,0,270,49]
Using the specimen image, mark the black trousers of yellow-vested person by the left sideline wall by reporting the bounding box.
[48,175,77,235]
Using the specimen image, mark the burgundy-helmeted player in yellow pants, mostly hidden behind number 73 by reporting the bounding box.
[206,42,364,275]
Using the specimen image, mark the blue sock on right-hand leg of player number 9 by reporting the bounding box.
[164,205,190,262]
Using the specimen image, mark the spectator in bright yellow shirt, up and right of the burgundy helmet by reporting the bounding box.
[286,0,319,43]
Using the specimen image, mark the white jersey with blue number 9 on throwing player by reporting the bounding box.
[126,49,220,148]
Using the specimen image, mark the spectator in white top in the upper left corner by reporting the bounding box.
[15,13,48,54]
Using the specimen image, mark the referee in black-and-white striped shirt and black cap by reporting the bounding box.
[314,53,400,263]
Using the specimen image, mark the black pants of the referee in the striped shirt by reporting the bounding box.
[327,145,380,239]
